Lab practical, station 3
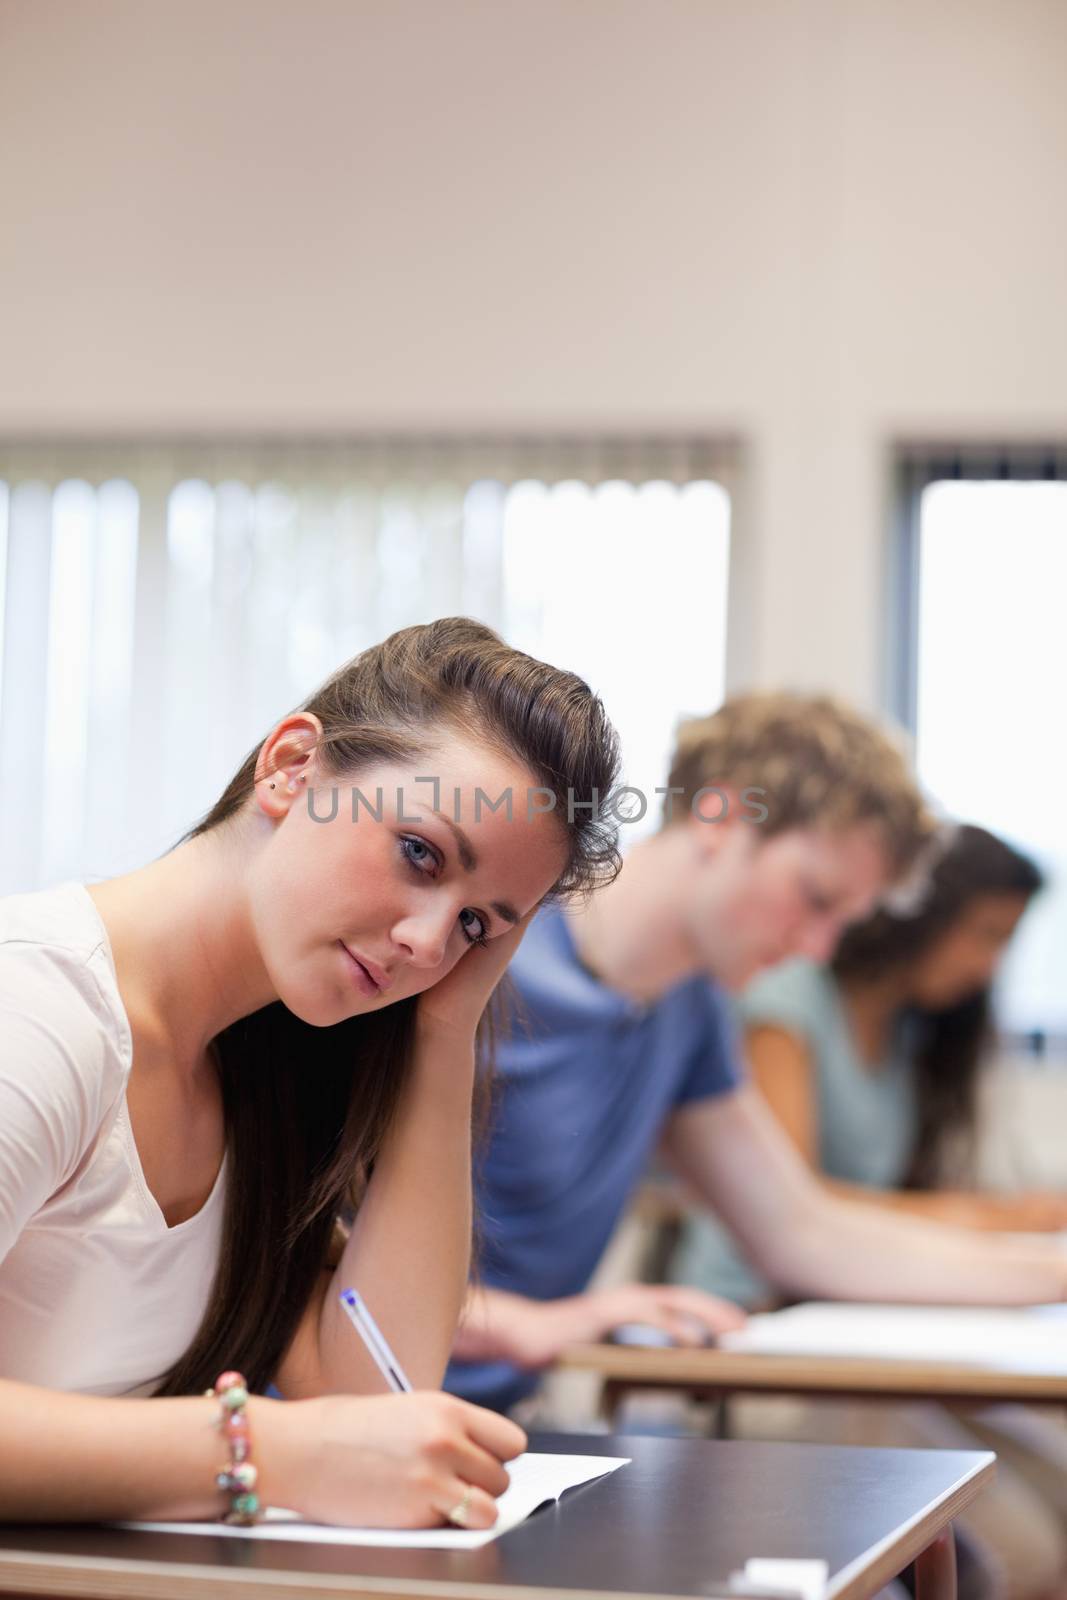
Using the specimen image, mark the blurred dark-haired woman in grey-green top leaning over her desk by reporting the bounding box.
[670,826,1067,1307]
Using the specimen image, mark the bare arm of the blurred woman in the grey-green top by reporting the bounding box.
[747,1024,1067,1234]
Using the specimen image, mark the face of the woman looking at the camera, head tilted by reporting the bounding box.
[250,734,566,1027]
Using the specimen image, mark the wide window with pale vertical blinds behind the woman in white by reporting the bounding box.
[0,440,729,893]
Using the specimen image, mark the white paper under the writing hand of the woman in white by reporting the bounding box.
[117,1451,630,1550]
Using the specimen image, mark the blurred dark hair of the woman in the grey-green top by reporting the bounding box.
[832,824,1043,1189]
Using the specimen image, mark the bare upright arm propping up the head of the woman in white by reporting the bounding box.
[277,925,525,1398]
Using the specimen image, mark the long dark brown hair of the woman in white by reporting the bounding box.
[155,618,619,1395]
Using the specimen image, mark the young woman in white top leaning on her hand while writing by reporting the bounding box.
[0,618,617,1526]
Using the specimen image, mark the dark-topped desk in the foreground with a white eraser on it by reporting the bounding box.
[0,1434,993,1600]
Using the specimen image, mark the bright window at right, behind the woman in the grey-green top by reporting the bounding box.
[901,456,1067,1040]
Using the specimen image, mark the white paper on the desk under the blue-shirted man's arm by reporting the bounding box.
[718,1301,1067,1374]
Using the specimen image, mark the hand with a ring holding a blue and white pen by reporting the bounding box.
[250,1392,526,1528]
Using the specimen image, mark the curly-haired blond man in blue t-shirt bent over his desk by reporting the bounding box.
[446,693,1067,1410]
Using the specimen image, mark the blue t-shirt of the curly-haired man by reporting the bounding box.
[445,906,741,1410]
